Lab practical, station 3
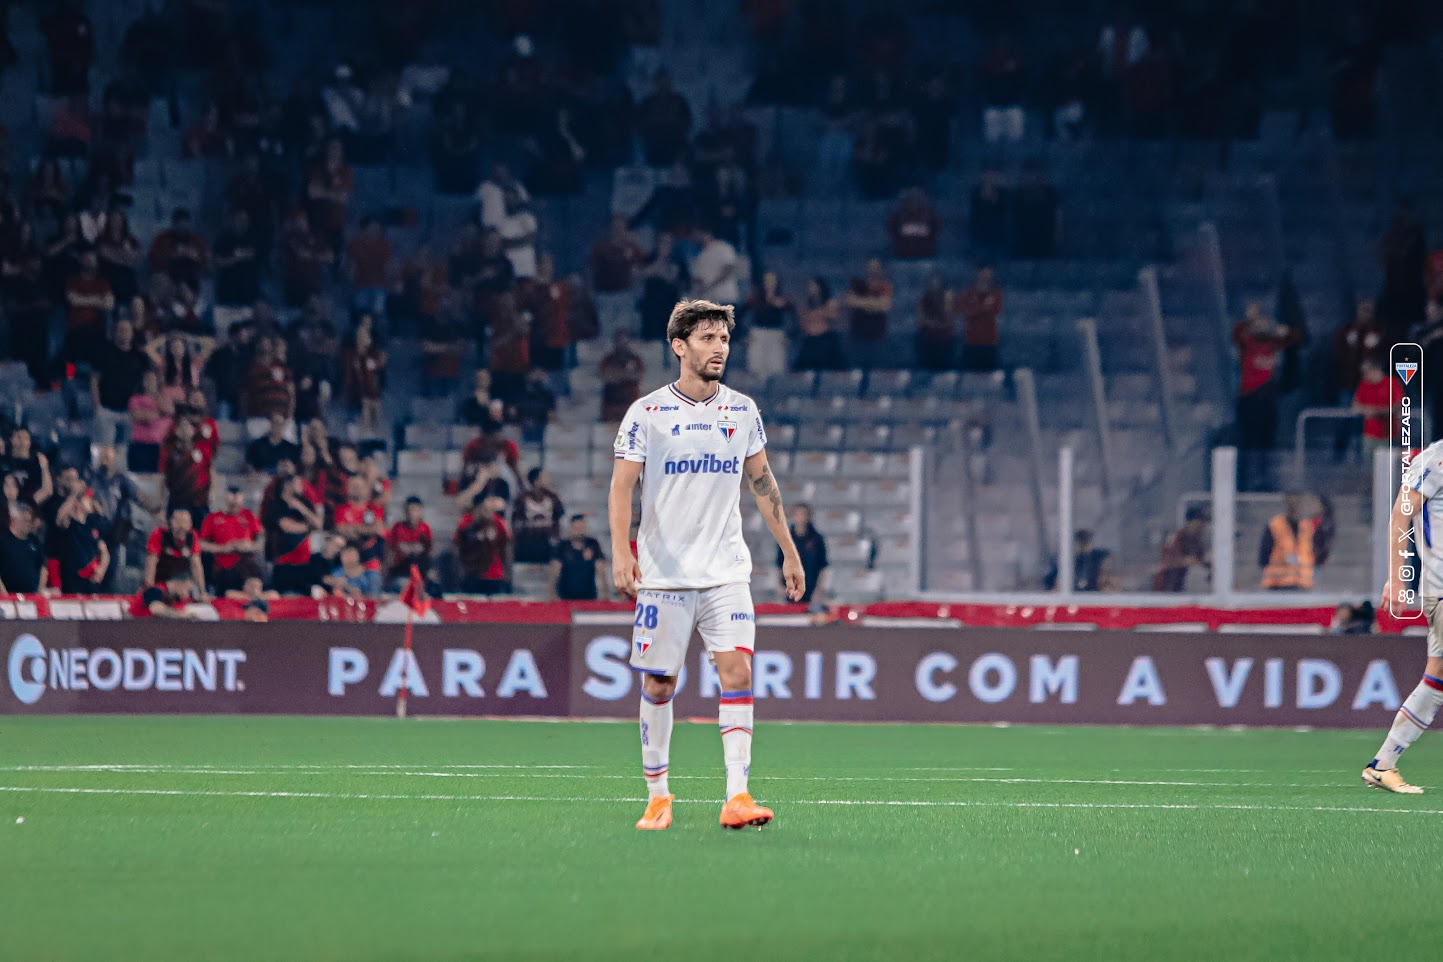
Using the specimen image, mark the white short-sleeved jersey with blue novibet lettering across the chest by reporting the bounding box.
[616,384,766,588]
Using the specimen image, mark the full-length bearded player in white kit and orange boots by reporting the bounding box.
[609,300,804,831]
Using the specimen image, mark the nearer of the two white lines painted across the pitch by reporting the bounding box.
[0,785,1443,815]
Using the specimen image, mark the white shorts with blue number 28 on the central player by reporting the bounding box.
[632,584,756,675]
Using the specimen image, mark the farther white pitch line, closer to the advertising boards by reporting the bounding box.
[0,764,1402,789]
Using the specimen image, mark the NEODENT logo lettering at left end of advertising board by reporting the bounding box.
[6,635,245,705]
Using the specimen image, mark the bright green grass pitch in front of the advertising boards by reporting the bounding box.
[0,717,1443,962]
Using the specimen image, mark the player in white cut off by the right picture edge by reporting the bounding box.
[1362,441,1443,795]
